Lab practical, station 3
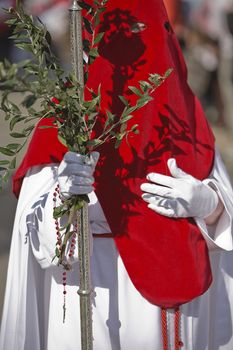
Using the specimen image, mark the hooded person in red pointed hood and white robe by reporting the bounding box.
[0,0,233,350]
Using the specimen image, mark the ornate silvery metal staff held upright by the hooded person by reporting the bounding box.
[70,0,93,350]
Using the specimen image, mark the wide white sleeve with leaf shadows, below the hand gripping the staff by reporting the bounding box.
[19,165,61,268]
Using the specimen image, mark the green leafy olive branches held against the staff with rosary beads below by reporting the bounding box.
[0,0,172,266]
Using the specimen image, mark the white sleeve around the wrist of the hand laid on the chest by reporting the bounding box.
[195,149,233,251]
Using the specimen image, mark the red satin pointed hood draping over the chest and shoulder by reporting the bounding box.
[14,0,214,307]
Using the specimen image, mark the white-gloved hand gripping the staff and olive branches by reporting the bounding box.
[58,152,99,198]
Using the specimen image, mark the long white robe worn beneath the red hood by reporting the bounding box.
[0,152,233,350]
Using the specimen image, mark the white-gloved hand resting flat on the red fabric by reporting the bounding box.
[141,158,219,219]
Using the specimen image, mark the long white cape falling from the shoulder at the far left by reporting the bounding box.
[0,166,58,350]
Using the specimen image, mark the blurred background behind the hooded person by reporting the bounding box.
[0,0,233,317]
